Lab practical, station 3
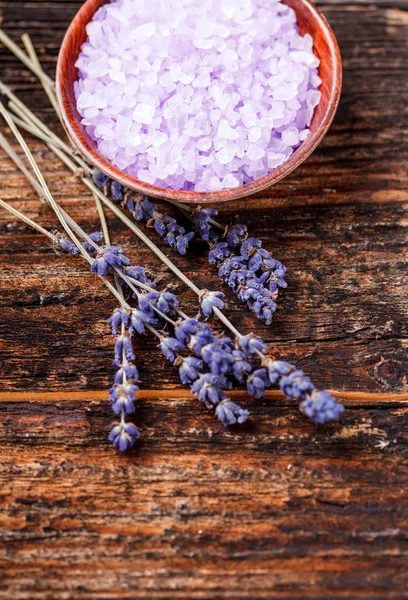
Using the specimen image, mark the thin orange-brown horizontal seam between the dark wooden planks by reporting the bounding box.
[0,389,408,408]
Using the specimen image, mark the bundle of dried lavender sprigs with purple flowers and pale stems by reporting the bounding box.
[0,29,343,450]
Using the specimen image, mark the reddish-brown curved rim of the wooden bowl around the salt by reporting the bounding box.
[56,0,342,204]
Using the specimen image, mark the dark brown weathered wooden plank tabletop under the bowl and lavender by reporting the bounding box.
[0,0,408,600]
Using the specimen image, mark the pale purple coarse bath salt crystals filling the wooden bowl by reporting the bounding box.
[75,0,321,192]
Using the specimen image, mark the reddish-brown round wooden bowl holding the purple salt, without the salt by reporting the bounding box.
[56,0,342,205]
